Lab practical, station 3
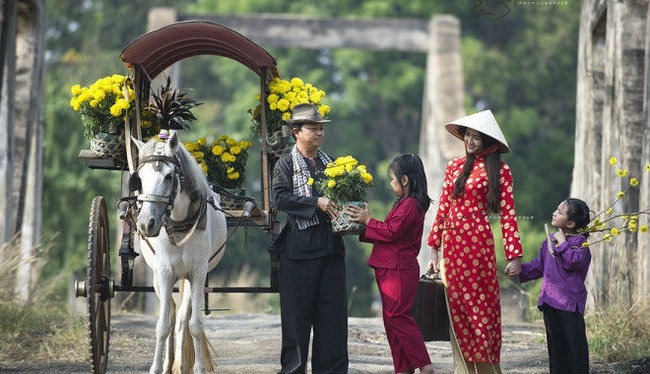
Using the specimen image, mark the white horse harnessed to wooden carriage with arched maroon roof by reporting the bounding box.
[76,21,279,373]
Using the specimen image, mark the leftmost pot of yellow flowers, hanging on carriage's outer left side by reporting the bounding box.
[70,74,133,158]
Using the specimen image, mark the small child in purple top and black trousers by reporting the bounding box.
[509,198,591,374]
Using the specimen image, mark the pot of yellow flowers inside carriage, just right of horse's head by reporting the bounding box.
[185,135,253,209]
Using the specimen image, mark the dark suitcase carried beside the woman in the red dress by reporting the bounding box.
[411,269,449,342]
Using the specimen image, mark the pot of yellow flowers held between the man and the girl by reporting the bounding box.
[316,156,372,235]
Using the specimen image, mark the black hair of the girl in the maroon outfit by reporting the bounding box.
[388,155,431,212]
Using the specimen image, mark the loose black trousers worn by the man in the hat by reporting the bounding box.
[278,256,349,374]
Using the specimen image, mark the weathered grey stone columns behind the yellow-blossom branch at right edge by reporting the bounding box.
[571,0,650,307]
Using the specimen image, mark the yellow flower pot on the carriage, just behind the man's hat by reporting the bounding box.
[248,78,330,157]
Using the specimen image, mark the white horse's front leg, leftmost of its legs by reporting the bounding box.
[149,267,174,374]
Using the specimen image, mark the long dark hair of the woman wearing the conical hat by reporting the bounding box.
[454,127,501,213]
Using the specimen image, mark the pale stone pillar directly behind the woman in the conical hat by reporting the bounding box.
[418,16,465,271]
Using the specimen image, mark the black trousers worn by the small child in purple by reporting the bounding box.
[542,304,589,374]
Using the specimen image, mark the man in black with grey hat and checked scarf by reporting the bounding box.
[273,104,349,374]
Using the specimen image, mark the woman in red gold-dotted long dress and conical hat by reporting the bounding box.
[428,110,523,373]
